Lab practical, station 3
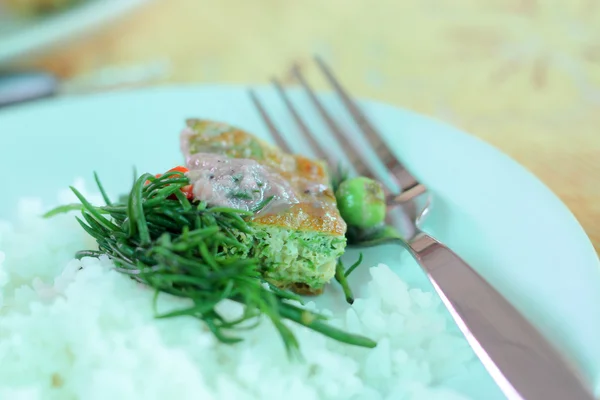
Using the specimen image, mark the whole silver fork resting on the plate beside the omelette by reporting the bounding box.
[250,57,594,400]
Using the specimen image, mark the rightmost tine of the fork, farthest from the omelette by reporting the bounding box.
[315,56,418,190]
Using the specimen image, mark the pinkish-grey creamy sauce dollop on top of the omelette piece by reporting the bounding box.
[187,153,300,213]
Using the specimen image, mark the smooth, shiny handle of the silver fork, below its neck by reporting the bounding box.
[407,233,594,400]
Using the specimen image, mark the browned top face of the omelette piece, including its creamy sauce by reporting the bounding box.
[180,120,346,235]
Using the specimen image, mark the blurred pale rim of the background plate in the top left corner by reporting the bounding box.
[0,0,149,64]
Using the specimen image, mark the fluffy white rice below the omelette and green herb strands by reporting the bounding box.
[0,184,472,400]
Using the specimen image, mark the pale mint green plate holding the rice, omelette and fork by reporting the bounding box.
[0,86,600,399]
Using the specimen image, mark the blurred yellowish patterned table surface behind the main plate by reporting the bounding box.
[10,0,600,250]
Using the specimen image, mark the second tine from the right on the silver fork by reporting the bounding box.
[292,65,369,180]
